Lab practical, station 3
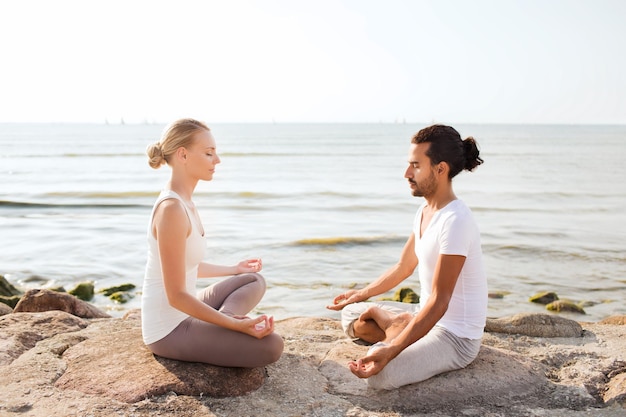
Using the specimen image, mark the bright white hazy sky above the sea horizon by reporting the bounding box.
[0,0,626,124]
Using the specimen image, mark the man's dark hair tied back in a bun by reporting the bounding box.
[411,125,483,179]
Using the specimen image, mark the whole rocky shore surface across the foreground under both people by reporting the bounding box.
[0,311,626,417]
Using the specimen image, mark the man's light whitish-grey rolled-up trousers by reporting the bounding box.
[341,301,481,389]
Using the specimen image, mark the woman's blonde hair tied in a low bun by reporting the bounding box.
[146,119,211,169]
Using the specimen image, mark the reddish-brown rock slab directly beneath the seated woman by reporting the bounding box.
[55,318,265,403]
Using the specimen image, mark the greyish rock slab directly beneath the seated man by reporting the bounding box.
[320,330,548,413]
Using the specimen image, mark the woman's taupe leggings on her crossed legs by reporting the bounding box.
[148,273,283,368]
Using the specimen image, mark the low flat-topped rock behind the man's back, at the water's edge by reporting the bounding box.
[485,313,583,337]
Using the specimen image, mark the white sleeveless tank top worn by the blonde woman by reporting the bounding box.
[141,190,206,345]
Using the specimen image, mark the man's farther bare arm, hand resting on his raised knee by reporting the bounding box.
[326,233,418,310]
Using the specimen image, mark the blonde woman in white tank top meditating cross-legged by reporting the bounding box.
[141,119,283,368]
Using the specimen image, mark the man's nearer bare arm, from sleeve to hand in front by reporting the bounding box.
[349,255,465,378]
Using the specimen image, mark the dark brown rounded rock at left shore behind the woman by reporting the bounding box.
[13,289,111,318]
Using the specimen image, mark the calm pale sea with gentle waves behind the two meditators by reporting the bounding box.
[0,123,626,321]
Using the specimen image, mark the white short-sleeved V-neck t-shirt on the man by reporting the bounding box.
[413,200,487,339]
